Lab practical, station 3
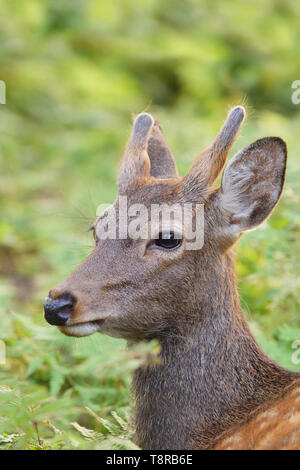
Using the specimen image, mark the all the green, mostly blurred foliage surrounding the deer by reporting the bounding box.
[0,0,300,449]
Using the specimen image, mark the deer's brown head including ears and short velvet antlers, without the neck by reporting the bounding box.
[45,107,286,340]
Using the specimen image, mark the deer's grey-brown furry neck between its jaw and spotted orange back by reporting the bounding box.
[133,252,295,449]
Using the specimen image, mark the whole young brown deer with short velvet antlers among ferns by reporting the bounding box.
[45,106,300,449]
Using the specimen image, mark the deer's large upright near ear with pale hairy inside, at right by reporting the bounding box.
[217,137,287,234]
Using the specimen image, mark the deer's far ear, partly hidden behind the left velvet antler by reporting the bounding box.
[148,121,178,178]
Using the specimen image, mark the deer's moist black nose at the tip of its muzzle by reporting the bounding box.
[44,293,76,326]
